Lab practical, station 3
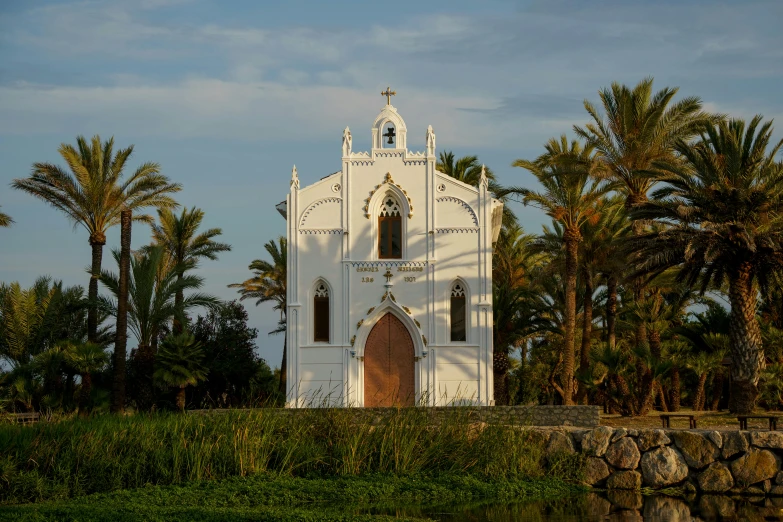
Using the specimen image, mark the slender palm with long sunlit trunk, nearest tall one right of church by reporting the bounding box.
[508,135,608,405]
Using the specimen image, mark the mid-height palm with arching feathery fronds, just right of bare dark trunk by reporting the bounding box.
[101,246,220,409]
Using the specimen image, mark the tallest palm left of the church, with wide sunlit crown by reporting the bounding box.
[11,135,181,342]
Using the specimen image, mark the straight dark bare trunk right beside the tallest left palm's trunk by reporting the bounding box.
[112,209,133,413]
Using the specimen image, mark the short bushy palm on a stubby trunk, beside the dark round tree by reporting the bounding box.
[154,332,208,411]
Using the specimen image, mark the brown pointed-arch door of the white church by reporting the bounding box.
[364,313,416,408]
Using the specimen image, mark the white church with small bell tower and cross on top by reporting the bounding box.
[277,89,502,407]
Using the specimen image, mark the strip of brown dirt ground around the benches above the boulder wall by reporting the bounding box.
[601,408,783,430]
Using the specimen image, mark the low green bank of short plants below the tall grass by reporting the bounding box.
[0,474,580,521]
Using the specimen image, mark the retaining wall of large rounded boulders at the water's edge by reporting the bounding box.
[534,426,783,496]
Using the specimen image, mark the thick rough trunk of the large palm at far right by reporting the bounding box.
[729,263,764,414]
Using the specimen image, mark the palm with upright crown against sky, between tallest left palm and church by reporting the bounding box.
[152,207,231,334]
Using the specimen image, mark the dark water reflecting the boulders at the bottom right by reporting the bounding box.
[354,491,783,522]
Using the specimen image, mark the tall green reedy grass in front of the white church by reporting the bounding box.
[0,408,576,503]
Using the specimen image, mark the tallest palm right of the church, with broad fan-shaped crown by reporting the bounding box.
[574,77,721,343]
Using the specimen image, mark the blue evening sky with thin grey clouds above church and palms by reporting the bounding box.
[0,0,783,366]
